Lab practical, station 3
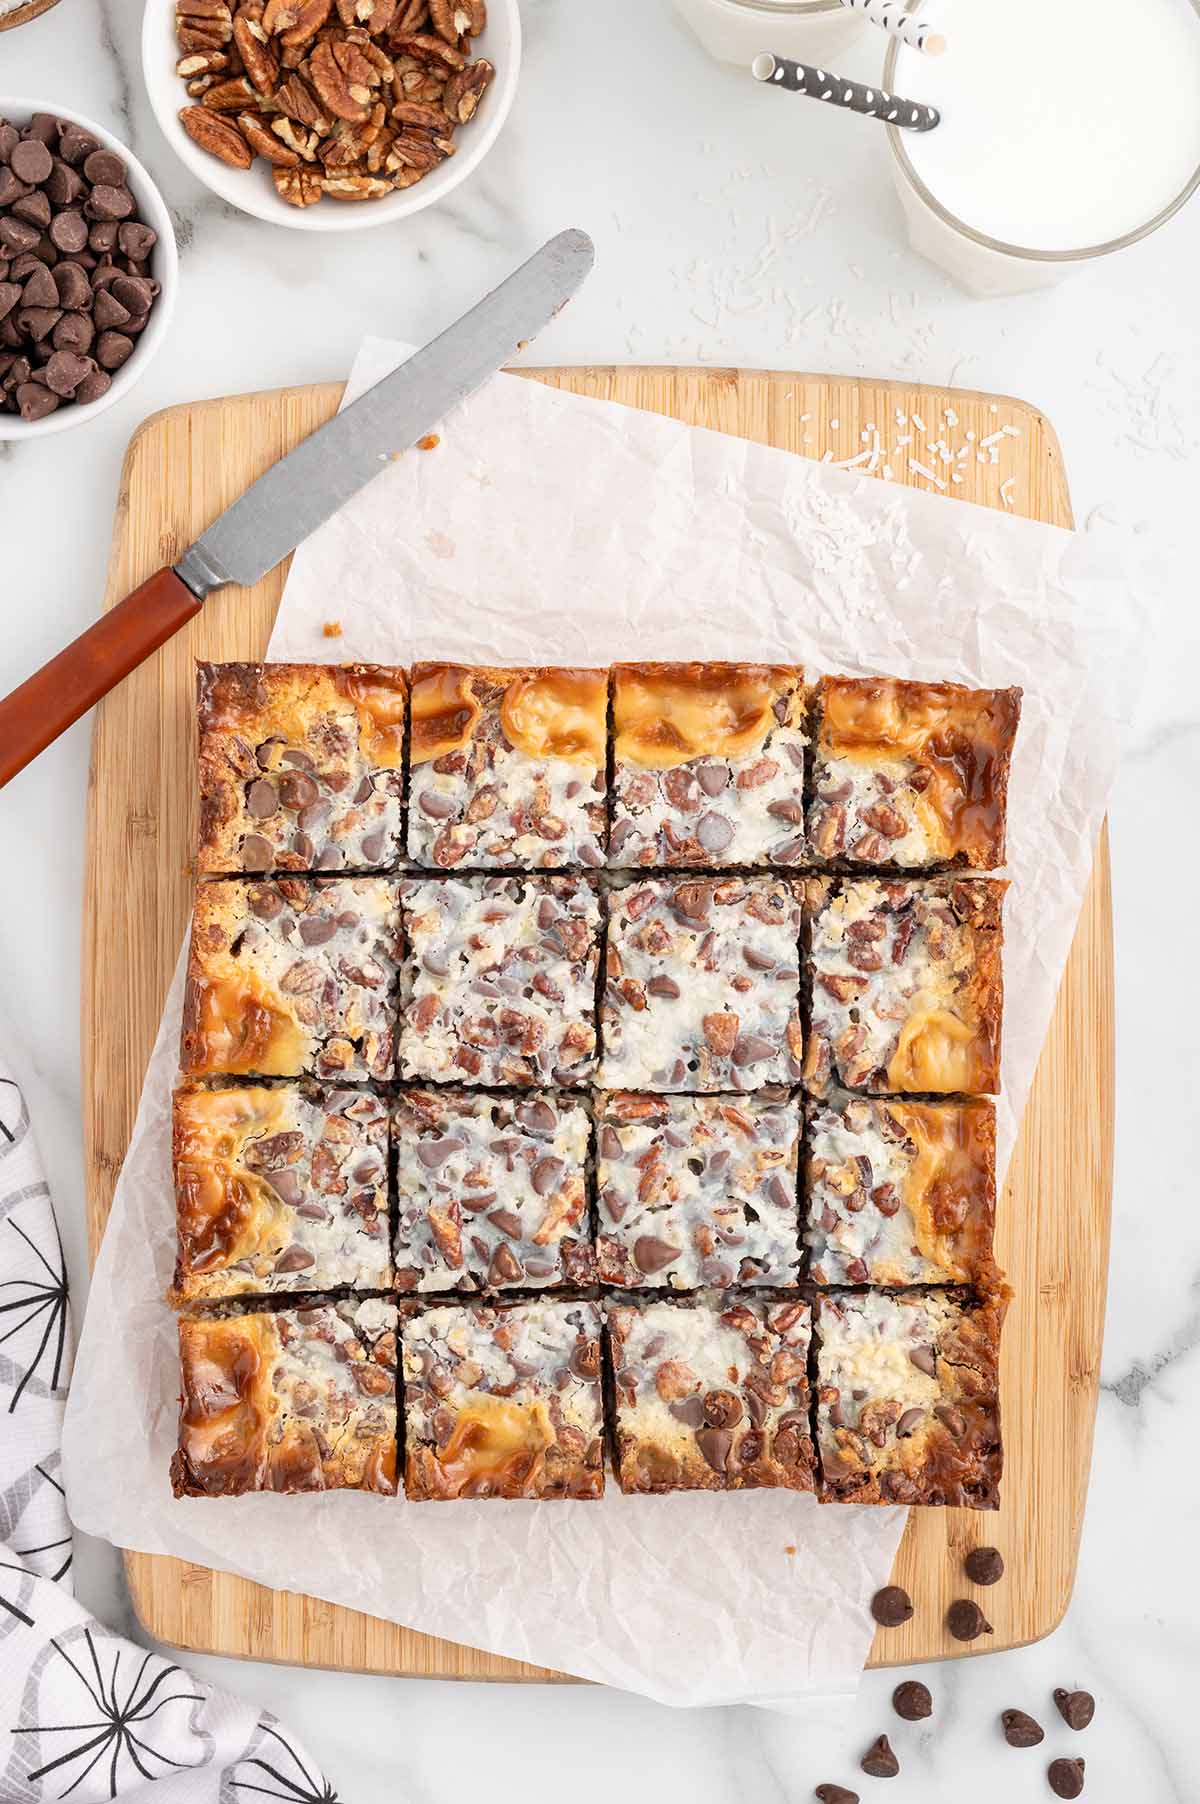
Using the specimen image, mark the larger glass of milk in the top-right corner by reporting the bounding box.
[882,0,1200,296]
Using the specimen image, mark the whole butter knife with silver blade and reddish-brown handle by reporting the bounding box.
[0,231,595,788]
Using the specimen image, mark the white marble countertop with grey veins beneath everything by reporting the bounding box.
[0,0,1200,1804]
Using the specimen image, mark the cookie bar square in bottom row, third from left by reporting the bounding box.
[606,1299,814,1492]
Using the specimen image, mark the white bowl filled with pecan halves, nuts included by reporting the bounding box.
[143,0,522,231]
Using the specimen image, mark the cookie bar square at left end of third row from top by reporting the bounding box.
[173,1084,392,1302]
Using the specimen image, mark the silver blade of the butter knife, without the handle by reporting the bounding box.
[175,231,595,599]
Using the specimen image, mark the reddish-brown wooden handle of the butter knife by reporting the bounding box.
[0,566,204,788]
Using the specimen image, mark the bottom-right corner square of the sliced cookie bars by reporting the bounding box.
[816,1290,1005,1510]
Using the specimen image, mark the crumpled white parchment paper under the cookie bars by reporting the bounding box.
[63,341,1151,1707]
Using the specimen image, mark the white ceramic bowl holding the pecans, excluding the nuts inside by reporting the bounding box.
[143,0,522,231]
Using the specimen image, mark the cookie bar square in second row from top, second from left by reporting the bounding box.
[401,877,599,1084]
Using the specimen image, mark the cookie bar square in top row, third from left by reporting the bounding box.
[608,664,807,866]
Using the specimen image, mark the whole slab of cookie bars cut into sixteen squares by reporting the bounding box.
[171,662,1020,1508]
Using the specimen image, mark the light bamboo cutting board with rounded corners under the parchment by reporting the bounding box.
[83,368,1113,1681]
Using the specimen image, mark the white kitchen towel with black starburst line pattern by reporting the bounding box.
[0,1052,337,1804]
